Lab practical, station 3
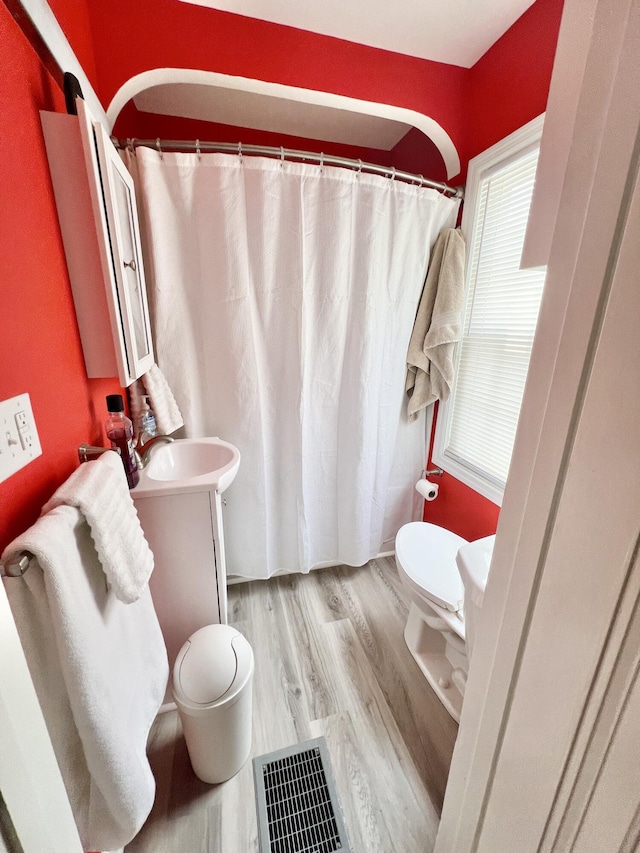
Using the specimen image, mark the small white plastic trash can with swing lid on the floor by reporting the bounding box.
[173,625,253,783]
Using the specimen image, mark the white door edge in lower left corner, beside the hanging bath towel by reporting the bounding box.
[0,578,82,853]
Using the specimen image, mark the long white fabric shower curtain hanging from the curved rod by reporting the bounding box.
[137,148,457,578]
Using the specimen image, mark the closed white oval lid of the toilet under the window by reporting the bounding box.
[396,521,467,613]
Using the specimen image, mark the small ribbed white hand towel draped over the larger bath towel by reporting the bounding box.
[42,451,153,604]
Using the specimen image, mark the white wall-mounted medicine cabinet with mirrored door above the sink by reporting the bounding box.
[40,99,154,387]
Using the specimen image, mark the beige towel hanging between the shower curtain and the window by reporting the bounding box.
[405,228,465,421]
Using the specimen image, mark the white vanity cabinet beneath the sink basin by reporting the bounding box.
[131,489,227,666]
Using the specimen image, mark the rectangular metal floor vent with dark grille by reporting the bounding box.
[253,738,351,853]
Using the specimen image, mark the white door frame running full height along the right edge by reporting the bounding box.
[435,0,640,853]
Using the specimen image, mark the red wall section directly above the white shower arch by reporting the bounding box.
[90,0,469,178]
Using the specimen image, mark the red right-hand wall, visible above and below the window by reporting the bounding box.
[424,0,563,540]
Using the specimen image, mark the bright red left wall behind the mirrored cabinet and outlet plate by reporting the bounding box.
[0,3,118,550]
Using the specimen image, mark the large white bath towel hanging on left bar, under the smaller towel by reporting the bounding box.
[2,506,169,850]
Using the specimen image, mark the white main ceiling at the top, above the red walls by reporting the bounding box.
[174,0,534,68]
